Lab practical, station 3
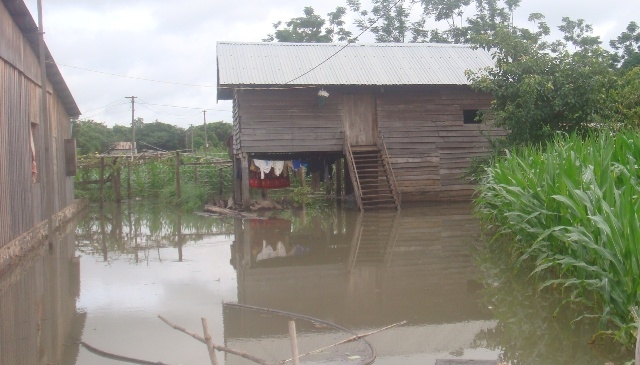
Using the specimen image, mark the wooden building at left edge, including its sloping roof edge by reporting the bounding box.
[0,0,80,253]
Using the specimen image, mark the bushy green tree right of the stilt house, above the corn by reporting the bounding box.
[468,18,616,145]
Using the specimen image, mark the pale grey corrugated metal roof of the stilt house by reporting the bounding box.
[217,42,493,99]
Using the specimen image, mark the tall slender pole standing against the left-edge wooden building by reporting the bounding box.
[38,0,56,247]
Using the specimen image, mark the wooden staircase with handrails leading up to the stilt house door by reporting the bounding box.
[345,136,400,211]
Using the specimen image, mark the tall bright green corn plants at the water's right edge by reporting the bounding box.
[475,131,640,345]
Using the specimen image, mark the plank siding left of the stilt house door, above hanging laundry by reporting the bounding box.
[234,88,344,153]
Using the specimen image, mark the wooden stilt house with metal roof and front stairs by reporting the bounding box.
[217,42,504,209]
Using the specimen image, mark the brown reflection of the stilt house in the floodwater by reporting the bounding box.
[224,203,496,363]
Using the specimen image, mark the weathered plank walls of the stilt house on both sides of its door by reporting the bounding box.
[234,86,505,201]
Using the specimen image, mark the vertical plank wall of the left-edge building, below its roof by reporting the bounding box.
[0,2,73,248]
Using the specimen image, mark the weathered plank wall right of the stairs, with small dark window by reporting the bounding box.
[377,86,505,201]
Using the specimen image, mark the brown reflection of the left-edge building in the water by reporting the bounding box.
[0,218,85,365]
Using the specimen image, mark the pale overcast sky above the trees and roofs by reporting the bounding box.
[25,0,640,128]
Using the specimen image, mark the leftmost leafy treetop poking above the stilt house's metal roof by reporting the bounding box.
[262,6,351,43]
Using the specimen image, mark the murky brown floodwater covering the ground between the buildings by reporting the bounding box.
[0,203,630,365]
